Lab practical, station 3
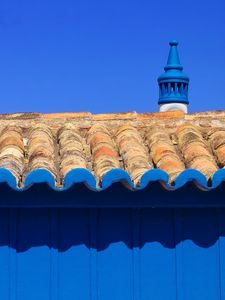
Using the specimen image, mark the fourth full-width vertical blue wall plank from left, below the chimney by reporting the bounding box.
[140,208,177,300]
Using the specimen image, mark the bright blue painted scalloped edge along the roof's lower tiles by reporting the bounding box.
[0,168,225,191]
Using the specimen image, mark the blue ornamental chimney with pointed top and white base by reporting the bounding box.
[158,41,189,113]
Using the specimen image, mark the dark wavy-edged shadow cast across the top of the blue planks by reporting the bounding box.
[0,204,222,252]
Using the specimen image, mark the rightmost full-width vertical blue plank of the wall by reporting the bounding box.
[183,208,220,300]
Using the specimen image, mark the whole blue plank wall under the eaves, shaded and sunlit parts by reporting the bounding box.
[0,187,225,300]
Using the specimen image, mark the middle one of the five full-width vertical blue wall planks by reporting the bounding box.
[98,208,134,300]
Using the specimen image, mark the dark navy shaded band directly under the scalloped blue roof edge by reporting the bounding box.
[0,182,225,208]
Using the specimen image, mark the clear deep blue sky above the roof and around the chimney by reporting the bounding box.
[0,0,225,113]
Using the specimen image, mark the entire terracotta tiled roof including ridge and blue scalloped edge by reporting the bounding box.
[0,111,225,191]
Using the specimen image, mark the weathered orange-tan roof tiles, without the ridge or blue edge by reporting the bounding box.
[0,113,225,188]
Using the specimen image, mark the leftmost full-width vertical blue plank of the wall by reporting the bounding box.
[16,208,51,300]
